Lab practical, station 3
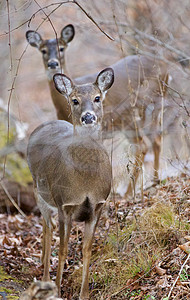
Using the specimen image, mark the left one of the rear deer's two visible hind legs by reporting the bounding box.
[125,137,148,197]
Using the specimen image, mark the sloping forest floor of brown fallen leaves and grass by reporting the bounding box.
[0,174,190,300]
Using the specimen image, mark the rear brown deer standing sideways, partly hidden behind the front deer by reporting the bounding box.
[26,25,169,197]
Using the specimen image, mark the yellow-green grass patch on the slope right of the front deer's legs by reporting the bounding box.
[70,202,190,299]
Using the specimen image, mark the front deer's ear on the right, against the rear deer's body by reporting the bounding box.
[96,68,114,92]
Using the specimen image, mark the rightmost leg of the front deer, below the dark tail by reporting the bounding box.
[79,201,105,300]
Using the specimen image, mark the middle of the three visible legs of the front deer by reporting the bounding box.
[56,209,71,296]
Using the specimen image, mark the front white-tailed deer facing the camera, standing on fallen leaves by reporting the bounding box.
[27,68,114,299]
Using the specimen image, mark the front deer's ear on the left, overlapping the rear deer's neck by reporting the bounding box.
[53,73,74,97]
